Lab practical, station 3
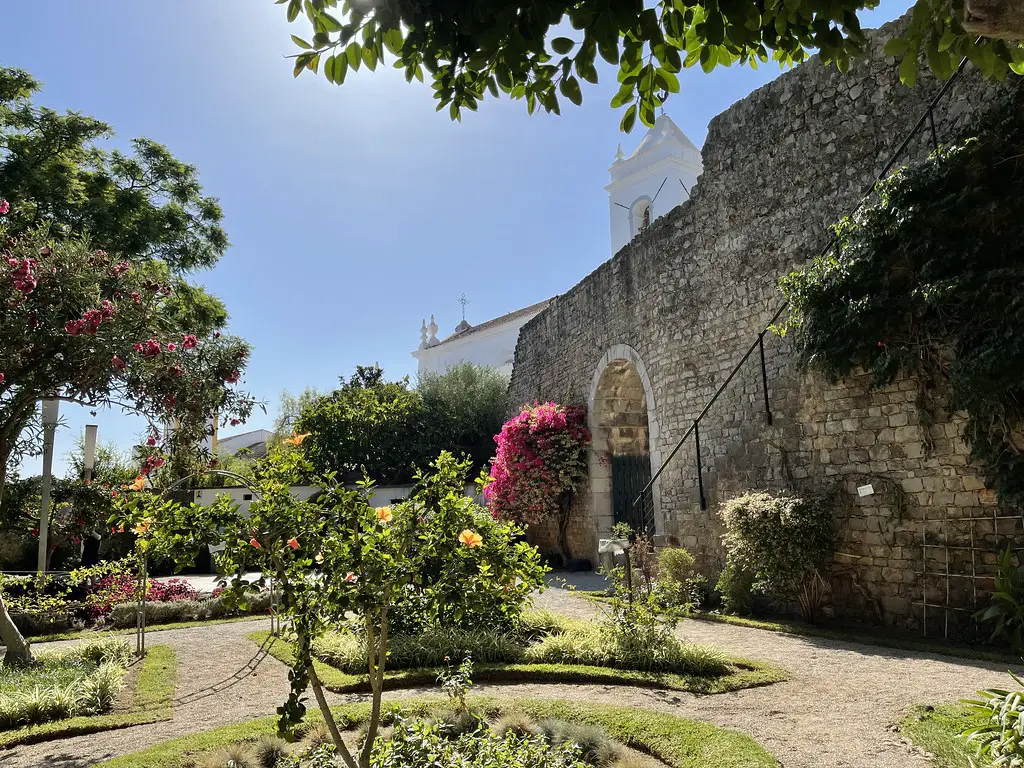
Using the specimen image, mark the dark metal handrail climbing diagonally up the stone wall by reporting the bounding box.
[633,51,980,531]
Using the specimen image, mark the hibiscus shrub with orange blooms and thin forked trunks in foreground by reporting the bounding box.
[121,444,543,768]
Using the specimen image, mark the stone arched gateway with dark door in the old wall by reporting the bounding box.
[587,344,665,537]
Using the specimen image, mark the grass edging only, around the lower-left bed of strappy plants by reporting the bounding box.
[0,645,178,750]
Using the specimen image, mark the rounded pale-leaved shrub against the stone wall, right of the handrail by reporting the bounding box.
[721,493,836,621]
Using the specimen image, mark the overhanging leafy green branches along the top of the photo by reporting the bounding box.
[276,0,1024,132]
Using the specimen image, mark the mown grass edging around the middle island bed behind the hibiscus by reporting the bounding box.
[246,632,788,694]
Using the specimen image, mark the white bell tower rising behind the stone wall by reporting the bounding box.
[604,115,703,255]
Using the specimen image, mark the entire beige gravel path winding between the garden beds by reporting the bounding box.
[0,589,1007,768]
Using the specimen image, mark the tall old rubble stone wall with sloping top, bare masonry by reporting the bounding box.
[509,20,1016,628]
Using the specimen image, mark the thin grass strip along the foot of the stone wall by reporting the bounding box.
[572,590,1021,666]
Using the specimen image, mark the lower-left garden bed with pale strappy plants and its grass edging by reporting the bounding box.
[0,640,176,748]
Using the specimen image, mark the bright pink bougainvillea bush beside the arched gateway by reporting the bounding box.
[483,402,591,559]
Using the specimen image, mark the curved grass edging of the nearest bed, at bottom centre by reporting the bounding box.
[99,696,780,768]
